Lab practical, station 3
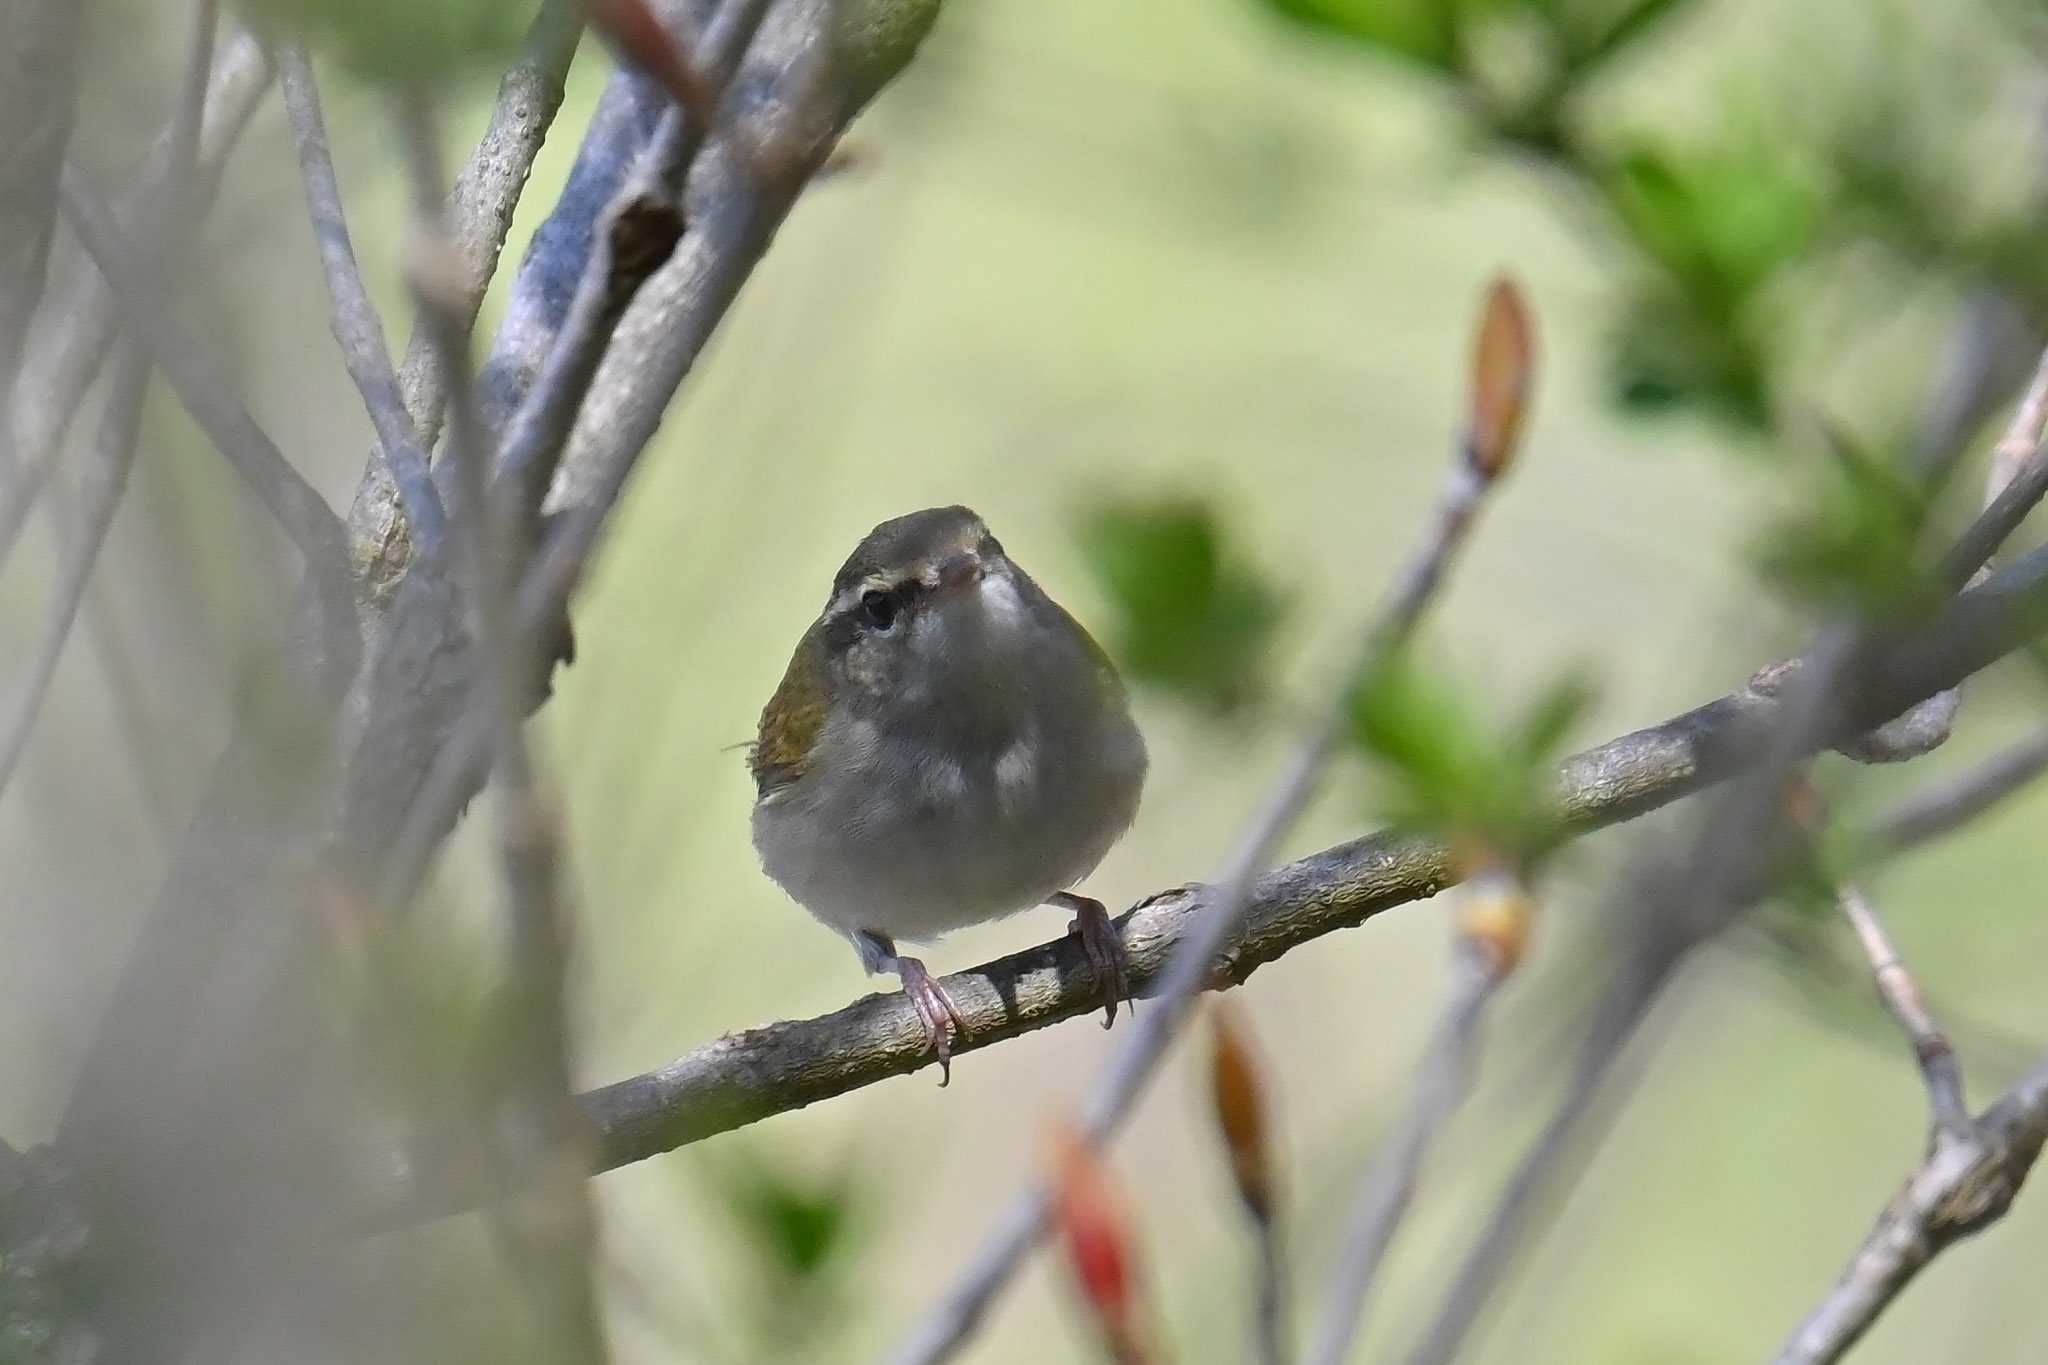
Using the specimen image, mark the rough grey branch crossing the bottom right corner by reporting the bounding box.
[1778,1064,2048,1365]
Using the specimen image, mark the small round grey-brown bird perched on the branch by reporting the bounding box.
[748,508,1145,1085]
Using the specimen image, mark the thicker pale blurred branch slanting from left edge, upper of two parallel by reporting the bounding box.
[0,35,270,567]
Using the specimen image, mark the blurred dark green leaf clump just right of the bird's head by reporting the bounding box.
[1079,499,1286,714]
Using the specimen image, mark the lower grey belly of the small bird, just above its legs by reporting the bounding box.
[754,720,1145,939]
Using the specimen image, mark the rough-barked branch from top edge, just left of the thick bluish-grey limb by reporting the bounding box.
[348,0,584,606]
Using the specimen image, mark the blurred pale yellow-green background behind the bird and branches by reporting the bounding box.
[0,0,2048,1365]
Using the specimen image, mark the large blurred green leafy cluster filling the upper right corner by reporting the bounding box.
[1260,0,2048,434]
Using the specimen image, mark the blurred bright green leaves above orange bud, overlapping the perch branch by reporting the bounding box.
[1350,653,1593,864]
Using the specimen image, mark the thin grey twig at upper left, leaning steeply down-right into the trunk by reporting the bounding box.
[276,43,446,555]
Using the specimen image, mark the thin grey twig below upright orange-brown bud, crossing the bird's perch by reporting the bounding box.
[889,290,1520,1365]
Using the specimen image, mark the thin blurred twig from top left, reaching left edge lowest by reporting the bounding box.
[0,0,219,794]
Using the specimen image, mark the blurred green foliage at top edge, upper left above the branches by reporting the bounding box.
[231,0,537,80]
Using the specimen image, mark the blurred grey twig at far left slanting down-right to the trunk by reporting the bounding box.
[59,166,354,658]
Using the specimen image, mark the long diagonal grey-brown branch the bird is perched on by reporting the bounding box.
[371,501,2048,1222]
